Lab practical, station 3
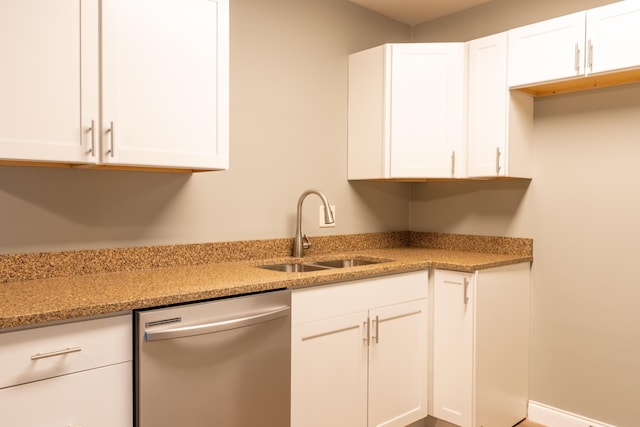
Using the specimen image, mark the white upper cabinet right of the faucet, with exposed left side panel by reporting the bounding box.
[348,43,466,179]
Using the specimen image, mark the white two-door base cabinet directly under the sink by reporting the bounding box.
[291,271,428,427]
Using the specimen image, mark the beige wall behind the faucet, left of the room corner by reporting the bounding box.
[0,0,410,253]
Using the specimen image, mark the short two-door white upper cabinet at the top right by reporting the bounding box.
[509,0,640,89]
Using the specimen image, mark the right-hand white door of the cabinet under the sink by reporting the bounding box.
[369,299,428,427]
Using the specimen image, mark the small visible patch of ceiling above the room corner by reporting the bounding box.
[350,0,491,26]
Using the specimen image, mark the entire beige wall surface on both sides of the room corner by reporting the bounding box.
[0,0,640,426]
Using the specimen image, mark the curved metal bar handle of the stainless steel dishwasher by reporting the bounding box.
[144,305,291,341]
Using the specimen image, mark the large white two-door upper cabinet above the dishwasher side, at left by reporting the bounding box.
[0,0,229,170]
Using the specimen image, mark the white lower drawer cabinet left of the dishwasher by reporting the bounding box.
[0,315,133,427]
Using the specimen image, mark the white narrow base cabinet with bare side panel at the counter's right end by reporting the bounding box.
[430,262,530,427]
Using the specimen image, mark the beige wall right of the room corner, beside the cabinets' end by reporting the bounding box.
[411,0,640,426]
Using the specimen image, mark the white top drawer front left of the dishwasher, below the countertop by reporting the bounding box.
[0,314,133,389]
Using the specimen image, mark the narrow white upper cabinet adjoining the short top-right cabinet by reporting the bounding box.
[467,32,533,178]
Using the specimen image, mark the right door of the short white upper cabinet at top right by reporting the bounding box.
[587,1,640,74]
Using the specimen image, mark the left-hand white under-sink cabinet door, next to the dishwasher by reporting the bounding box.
[291,312,367,427]
